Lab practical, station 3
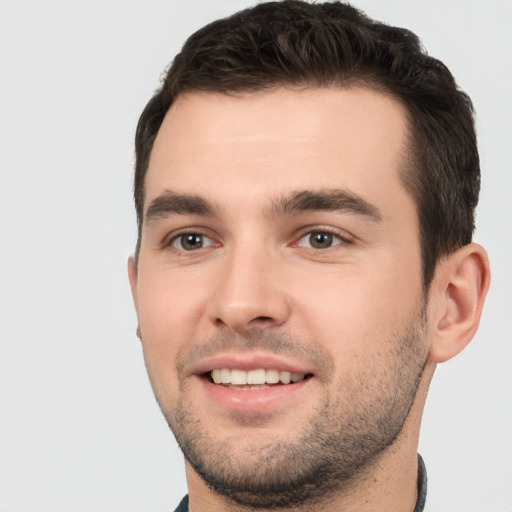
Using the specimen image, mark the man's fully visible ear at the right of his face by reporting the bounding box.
[430,243,490,363]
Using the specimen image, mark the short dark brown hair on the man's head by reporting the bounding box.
[134,0,480,291]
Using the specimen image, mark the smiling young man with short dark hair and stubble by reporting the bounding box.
[129,1,489,512]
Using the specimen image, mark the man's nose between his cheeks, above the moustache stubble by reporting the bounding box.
[207,247,290,334]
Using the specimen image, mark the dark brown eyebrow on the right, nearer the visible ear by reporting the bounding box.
[269,189,382,222]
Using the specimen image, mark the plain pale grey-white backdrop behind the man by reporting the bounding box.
[0,0,512,512]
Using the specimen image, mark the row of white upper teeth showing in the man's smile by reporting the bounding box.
[211,368,305,389]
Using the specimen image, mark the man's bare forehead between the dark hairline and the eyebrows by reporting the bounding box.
[145,87,408,214]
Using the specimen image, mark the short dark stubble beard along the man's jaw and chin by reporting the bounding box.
[151,309,426,510]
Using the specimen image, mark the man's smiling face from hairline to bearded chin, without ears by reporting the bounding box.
[130,88,427,507]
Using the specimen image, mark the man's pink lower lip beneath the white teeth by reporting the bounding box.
[201,377,313,413]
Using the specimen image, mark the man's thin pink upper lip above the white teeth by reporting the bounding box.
[191,352,314,375]
